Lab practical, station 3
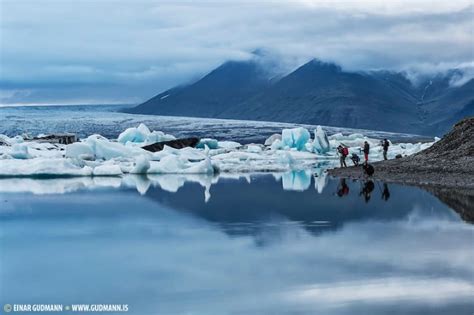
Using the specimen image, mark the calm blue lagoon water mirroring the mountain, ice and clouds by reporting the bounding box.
[0,172,474,314]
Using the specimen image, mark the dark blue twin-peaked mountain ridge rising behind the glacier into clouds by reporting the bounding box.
[129,60,474,135]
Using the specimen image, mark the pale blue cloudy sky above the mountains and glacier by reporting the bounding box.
[0,0,474,104]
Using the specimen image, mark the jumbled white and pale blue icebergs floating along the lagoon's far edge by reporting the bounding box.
[0,124,436,178]
